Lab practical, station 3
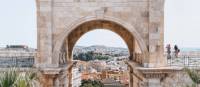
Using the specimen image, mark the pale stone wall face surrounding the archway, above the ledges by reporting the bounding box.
[36,0,166,67]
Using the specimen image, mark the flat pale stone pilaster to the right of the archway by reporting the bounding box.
[148,0,167,67]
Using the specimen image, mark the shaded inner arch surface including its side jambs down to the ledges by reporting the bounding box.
[61,20,144,64]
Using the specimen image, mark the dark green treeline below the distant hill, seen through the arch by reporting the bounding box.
[73,52,110,61]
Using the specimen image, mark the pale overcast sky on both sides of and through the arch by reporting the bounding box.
[0,0,200,48]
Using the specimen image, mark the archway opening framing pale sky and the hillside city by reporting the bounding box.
[72,29,130,87]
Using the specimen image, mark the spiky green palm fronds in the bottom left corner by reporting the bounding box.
[0,69,37,87]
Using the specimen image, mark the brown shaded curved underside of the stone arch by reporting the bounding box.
[63,20,142,61]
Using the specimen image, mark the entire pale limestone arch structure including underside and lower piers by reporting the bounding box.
[24,0,194,87]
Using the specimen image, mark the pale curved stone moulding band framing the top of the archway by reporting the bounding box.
[52,16,148,64]
